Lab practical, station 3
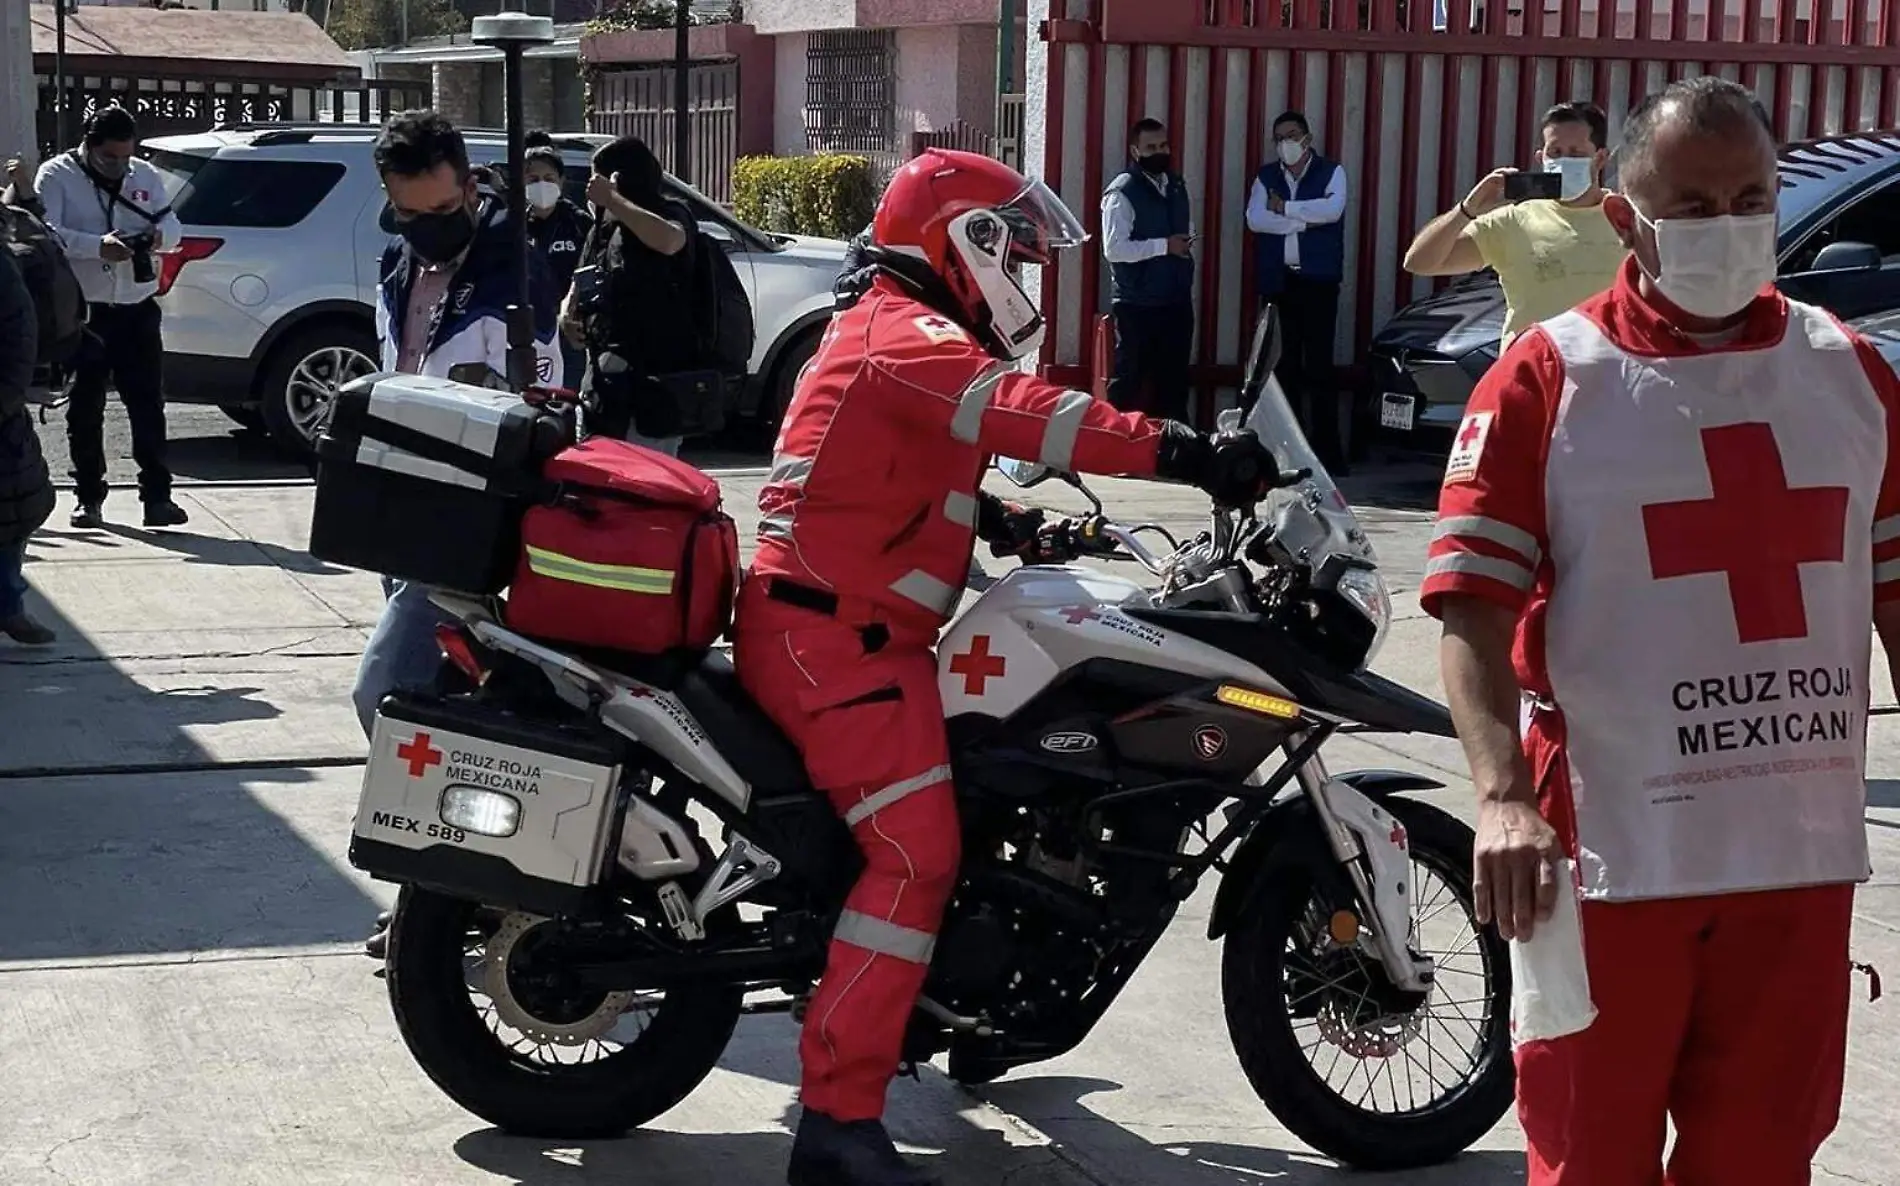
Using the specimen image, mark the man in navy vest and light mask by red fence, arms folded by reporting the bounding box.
[1243,112,1351,473]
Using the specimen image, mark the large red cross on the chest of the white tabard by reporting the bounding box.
[1644,422,1847,642]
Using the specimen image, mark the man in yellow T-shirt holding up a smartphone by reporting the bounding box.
[1404,103,1628,346]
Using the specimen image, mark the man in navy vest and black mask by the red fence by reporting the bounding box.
[1102,120,1195,420]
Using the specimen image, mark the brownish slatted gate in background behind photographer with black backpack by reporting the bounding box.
[587,61,739,203]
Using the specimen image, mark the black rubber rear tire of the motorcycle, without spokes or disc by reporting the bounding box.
[388,886,745,1140]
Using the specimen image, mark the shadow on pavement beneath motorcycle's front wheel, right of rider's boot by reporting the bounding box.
[977,1076,1524,1186]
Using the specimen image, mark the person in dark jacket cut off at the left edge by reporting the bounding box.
[0,234,55,646]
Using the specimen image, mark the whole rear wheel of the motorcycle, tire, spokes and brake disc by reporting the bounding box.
[388,886,745,1140]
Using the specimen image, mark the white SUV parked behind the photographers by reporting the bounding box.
[143,124,846,452]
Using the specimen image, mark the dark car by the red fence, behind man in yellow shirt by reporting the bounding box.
[1372,131,1900,449]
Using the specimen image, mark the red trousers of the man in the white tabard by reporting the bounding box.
[1518,886,1854,1186]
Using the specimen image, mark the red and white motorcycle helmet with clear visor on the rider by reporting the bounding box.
[870,148,1089,357]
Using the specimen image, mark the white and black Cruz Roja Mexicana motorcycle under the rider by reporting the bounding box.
[350,307,1512,1169]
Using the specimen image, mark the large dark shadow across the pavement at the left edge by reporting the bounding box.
[0,524,376,962]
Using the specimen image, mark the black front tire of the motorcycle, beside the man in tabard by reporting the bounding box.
[1222,798,1516,1171]
